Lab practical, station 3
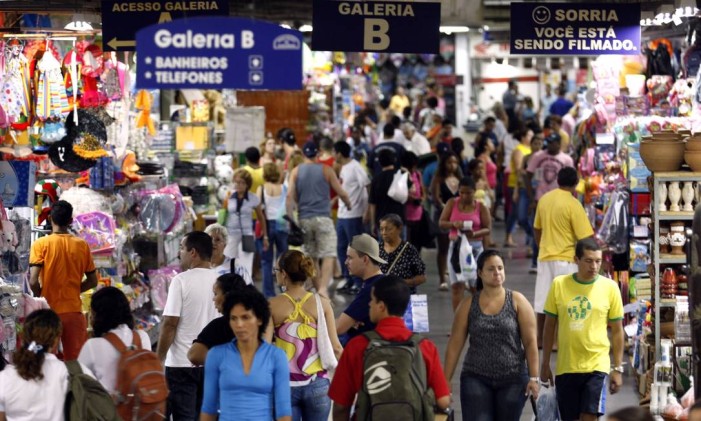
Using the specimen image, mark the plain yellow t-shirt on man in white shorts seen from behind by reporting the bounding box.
[533,188,594,262]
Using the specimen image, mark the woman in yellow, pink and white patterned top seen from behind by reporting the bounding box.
[270,250,343,421]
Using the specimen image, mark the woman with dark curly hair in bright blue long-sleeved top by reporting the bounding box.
[200,288,292,421]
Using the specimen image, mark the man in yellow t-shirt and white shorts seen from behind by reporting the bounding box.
[533,167,594,345]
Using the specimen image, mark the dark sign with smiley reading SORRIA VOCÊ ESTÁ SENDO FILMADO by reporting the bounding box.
[511,3,640,55]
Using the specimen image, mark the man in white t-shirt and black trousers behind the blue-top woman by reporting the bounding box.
[157,231,219,421]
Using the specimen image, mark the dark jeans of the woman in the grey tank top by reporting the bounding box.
[460,372,528,421]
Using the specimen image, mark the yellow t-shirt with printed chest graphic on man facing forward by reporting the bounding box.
[544,274,623,375]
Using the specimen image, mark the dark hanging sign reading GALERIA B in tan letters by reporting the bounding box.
[312,0,441,54]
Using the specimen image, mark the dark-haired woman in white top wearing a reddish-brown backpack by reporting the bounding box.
[78,287,151,396]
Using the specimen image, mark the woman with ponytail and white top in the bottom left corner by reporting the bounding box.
[0,310,91,421]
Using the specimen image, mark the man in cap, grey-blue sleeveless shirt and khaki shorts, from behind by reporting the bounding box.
[287,141,352,296]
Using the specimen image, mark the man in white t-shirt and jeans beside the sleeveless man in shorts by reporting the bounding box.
[333,142,370,292]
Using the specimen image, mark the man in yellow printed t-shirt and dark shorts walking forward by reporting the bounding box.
[540,238,623,421]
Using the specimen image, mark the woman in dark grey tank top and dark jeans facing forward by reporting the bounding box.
[445,249,540,421]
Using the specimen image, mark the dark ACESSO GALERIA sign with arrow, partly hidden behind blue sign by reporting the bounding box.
[101,0,229,51]
